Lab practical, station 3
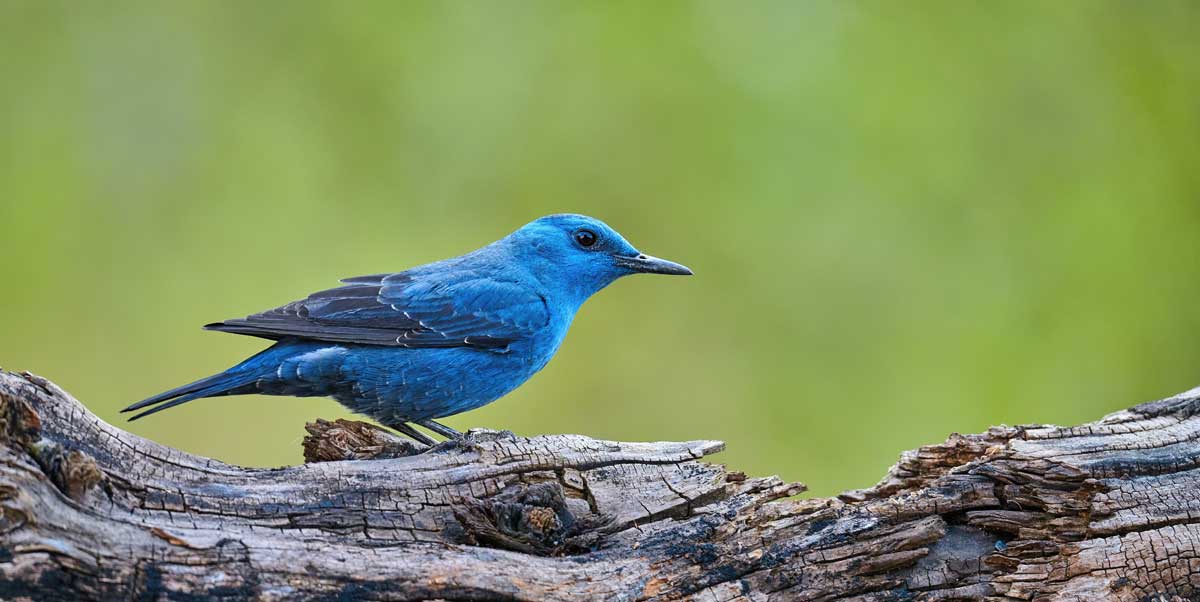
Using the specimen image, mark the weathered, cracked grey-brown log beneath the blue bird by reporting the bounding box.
[0,373,1200,602]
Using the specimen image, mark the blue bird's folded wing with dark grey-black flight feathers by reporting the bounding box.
[205,271,550,349]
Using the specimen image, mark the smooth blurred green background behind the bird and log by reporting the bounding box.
[0,0,1200,494]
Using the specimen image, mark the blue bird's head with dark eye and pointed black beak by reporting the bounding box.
[504,213,691,303]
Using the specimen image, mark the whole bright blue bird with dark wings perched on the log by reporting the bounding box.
[121,215,691,445]
